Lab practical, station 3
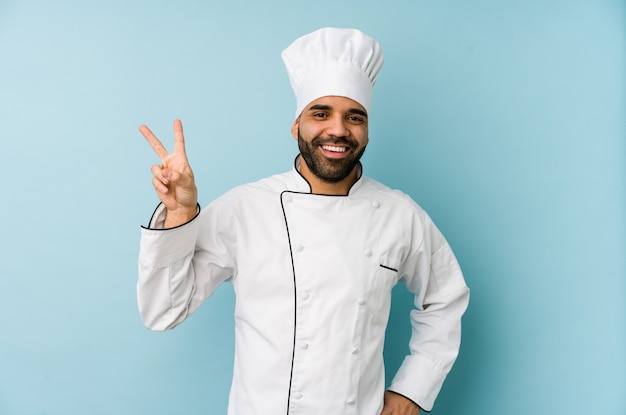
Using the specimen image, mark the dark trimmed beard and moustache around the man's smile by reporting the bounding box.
[298,129,366,183]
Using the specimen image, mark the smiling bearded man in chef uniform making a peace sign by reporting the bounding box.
[138,28,469,415]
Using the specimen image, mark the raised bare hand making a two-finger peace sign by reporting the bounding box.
[139,120,198,228]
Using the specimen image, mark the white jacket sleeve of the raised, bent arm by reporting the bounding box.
[137,202,234,331]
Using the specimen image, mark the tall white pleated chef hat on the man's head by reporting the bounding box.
[282,28,383,117]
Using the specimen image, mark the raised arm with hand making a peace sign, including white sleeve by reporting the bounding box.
[137,120,231,331]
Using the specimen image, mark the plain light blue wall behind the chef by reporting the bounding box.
[0,0,626,415]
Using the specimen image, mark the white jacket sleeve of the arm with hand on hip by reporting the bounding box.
[389,218,469,411]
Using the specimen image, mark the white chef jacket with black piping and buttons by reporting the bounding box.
[137,160,469,415]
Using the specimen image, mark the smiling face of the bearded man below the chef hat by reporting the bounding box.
[291,96,368,183]
